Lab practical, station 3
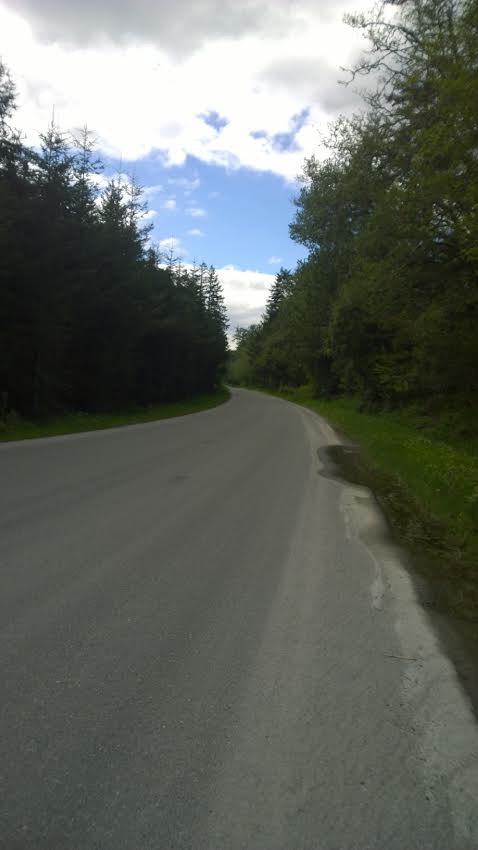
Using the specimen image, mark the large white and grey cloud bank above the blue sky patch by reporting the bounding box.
[0,0,369,177]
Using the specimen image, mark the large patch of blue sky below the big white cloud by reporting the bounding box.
[124,155,304,272]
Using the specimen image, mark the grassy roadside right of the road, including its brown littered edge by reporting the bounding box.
[264,387,478,620]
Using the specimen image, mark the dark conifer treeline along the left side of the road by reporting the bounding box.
[0,63,227,418]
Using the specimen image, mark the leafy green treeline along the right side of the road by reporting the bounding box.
[232,0,478,406]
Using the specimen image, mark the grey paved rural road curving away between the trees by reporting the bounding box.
[0,390,478,850]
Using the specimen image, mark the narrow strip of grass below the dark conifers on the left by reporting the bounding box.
[0,387,230,442]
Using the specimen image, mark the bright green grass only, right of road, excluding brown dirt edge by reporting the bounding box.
[268,388,478,568]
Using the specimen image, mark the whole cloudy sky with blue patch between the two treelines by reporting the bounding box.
[0,0,371,327]
